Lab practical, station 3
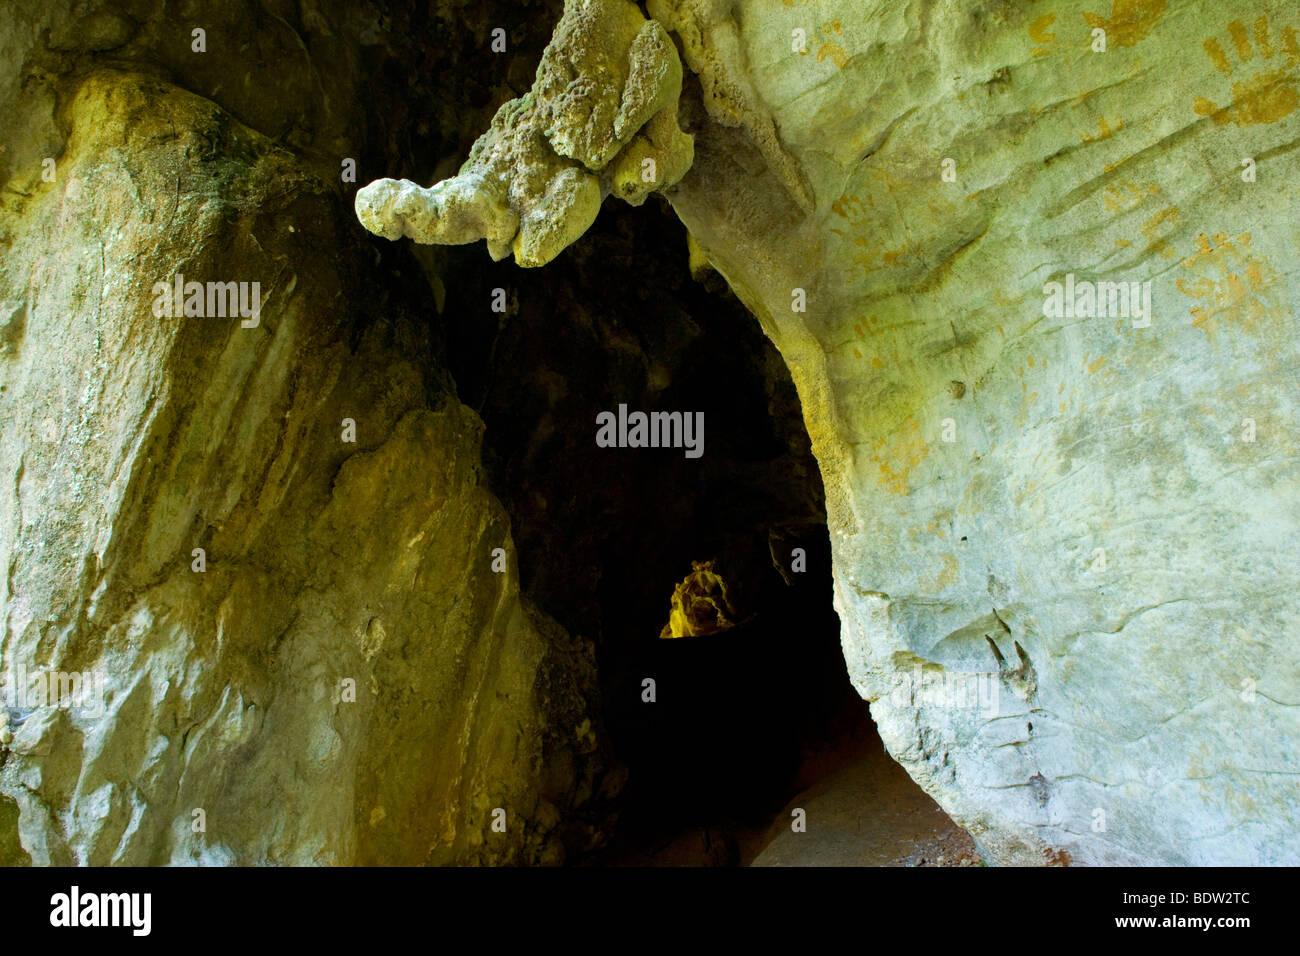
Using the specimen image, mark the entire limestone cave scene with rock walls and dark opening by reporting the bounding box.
[0,0,1300,868]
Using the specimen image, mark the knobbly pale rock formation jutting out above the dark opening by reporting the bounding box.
[356,0,693,267]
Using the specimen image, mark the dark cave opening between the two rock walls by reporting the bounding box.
[436,196,977,865]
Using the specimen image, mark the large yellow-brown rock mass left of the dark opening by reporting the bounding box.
[0,63,595,864]
